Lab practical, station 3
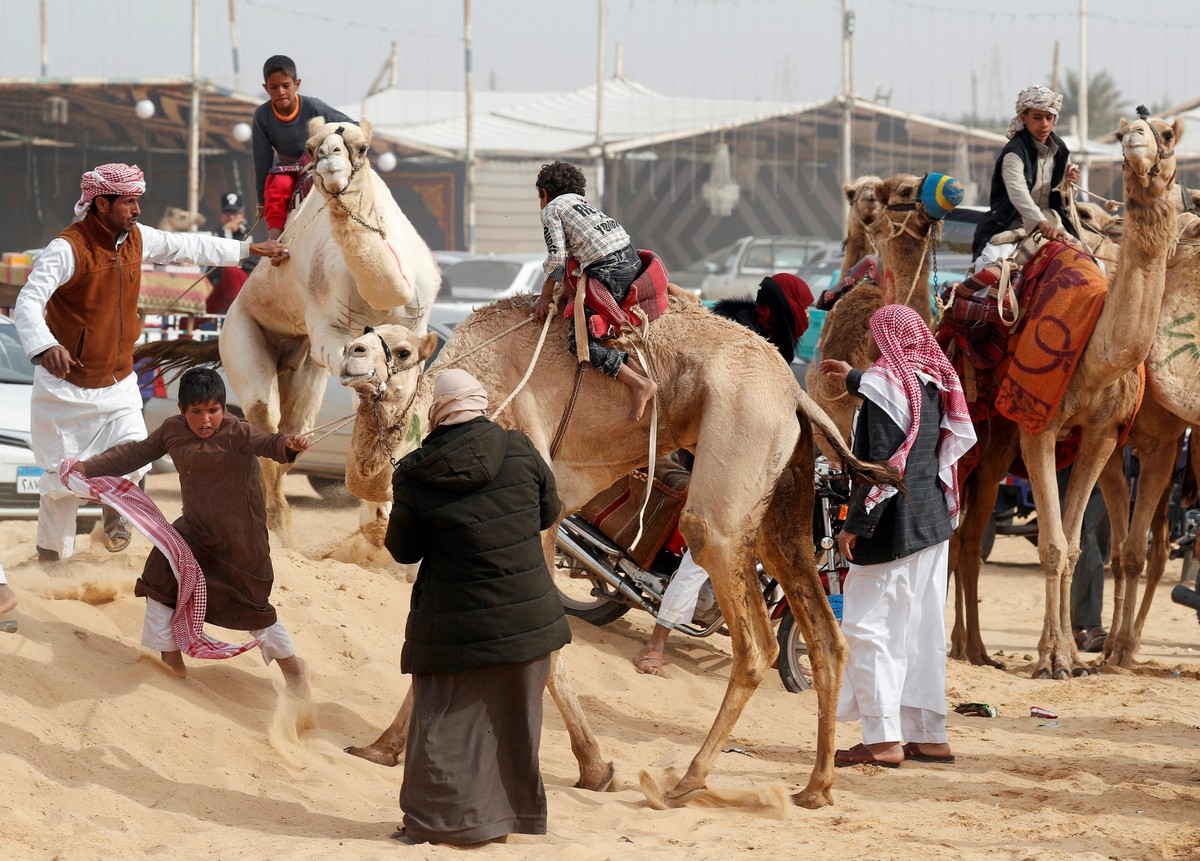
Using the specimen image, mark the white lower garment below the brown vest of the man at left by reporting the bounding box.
[30,366,146,559]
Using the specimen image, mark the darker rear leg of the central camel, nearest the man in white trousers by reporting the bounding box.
[758,428,848,809]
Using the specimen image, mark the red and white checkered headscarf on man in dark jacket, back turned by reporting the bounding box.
[859,305,976,525]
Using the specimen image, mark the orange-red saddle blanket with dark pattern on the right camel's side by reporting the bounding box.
[996,242,1108,433]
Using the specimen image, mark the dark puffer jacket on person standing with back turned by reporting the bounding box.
[385,417,571,673]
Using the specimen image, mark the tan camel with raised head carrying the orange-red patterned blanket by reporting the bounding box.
[1020,112,1183,679]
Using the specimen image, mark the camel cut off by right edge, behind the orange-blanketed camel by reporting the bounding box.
[1100,212,1200,667]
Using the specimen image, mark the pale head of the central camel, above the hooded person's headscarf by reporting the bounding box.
[340,324,438,401]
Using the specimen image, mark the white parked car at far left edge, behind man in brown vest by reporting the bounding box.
[0,315,100,532]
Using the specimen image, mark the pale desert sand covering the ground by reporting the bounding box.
[0,474,1200,861]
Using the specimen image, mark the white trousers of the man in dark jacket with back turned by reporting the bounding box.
[838,541,949,745]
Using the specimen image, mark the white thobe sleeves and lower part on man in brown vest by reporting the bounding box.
[13,224,250,559]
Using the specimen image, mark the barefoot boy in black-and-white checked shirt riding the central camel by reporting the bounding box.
[534,162,658,422]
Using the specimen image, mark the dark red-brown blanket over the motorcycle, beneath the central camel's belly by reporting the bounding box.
[580,457,691,568]
